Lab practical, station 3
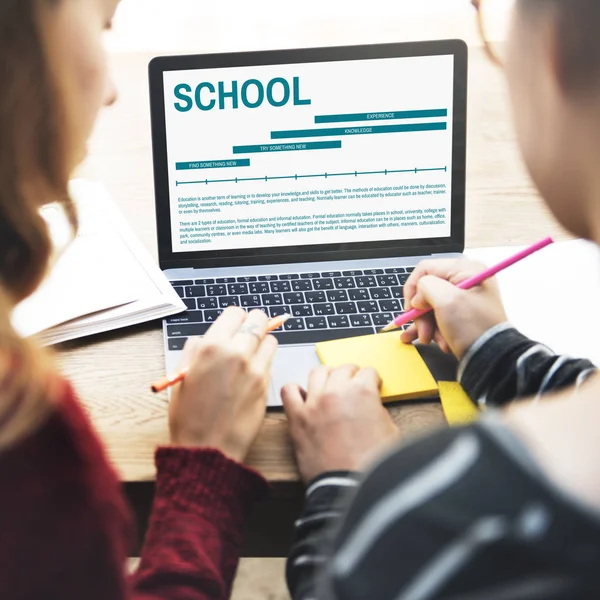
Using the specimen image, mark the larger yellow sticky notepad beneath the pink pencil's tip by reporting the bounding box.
[317,333,438,402]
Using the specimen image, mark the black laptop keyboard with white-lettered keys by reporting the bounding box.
[166,267,414,350]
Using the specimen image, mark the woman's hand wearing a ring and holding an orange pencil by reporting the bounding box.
[169,307,277,462]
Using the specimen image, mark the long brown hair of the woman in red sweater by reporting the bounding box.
[0,0,76,450]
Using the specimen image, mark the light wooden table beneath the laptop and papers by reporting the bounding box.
[58,49,566,555]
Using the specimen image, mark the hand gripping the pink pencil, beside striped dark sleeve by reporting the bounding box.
[401,259,507,359]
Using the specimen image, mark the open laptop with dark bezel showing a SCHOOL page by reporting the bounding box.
[149,40,467,406]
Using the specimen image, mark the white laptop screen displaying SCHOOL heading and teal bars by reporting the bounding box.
[163,54,455,253]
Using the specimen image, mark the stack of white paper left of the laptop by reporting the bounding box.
[12,180,186,344]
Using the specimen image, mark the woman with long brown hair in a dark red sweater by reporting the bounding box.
[0,0,277,600]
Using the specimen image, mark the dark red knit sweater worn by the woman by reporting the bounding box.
[0,385,267,600]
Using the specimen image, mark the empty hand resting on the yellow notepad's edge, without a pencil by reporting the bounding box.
[281,365,398,481]
